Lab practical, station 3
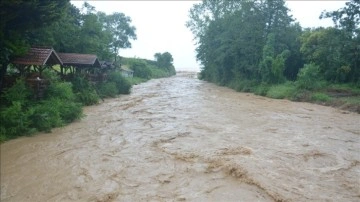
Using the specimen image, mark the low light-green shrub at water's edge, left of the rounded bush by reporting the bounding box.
[266,82,297,99]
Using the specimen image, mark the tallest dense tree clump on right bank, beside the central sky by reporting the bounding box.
[193,0,301,85]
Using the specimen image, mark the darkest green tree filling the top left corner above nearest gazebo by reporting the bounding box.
[0,0,69,92]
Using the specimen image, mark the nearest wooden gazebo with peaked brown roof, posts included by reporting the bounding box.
[11,47,63,99]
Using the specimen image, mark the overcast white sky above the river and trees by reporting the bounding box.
[71,0,346,71]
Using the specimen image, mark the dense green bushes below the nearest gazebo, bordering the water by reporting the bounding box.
[0,75,82,141]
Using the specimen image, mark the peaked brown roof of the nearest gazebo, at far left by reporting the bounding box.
[12,47,63,65]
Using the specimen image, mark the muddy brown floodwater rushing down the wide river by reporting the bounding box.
[1,73,360,202]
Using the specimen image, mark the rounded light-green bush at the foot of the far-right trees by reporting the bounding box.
[296,64,325,90]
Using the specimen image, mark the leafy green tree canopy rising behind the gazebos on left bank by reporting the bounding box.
[0,0,136,89]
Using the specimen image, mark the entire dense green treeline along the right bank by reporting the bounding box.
[187,0,360,90]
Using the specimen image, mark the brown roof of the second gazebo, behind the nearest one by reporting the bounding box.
[58,53,101,68]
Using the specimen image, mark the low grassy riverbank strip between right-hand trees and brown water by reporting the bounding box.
[222,78,360,114]
